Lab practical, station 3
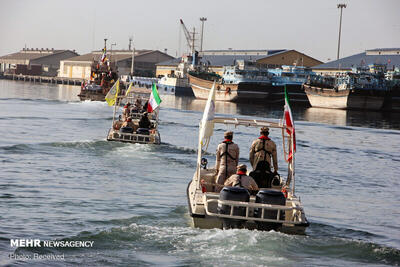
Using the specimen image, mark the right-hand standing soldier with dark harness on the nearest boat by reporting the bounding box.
[250,127,278,173]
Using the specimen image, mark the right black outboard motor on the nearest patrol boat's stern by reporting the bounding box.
[254,189,286,231]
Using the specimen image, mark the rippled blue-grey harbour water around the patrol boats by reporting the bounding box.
[0,80,400,266]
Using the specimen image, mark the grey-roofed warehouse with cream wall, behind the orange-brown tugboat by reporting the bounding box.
[58,50,173,79]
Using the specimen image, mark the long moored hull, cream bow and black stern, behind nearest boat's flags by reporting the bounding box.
[188,75,308,105]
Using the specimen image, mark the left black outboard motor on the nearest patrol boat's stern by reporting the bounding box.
[217,186,250,229]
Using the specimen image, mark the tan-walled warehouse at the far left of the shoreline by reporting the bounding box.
[0,48,79,76]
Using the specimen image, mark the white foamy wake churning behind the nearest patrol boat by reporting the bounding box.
[10,206,400,266]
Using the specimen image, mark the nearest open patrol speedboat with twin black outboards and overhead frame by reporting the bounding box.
[187,84,309,234]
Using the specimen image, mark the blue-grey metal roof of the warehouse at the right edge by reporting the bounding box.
[312,52,400,70]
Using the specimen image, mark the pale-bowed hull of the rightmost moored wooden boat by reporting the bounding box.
[304,84,387,110]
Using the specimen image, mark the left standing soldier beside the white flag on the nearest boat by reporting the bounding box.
[215,131,239,192]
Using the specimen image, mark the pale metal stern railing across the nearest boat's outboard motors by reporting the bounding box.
[205,199,305,224]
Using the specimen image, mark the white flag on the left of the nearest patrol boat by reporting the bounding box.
[199,81,215,146]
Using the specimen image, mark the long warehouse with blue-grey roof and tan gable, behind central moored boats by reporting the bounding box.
[156,49,322,76]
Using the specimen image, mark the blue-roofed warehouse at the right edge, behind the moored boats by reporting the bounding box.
[312,48,400,75]
